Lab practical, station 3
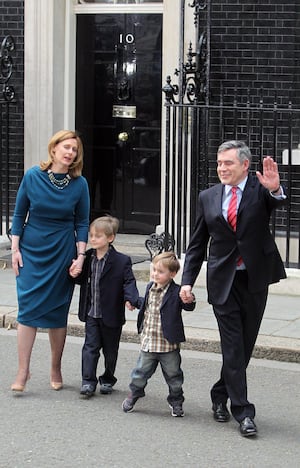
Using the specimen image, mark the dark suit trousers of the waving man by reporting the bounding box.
[211,270,268,422]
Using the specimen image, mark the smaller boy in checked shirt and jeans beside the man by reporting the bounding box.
[122,252,195,417]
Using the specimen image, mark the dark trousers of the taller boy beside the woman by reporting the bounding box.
[82,316,122,388]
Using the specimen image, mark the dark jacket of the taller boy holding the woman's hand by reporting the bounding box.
[75,246,139,327]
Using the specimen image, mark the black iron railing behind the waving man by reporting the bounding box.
[164,92,300,268]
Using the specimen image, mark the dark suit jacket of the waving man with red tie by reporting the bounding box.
[182,175,286,305]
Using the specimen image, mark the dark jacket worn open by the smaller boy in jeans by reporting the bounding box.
[137,280,196,343]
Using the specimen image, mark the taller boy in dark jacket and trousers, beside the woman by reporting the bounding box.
[70,216,139,398]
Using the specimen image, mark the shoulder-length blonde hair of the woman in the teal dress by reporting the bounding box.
[40,130,83,178]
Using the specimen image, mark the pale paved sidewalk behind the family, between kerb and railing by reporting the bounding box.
[0,234,300,363]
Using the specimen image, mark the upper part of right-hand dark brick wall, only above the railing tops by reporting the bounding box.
[211,0,300,106]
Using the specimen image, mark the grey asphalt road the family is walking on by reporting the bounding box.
[0,329,300,468]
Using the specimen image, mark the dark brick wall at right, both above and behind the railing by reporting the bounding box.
[196,0,300,238]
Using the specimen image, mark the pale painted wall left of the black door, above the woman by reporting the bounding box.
[24,0,75,170]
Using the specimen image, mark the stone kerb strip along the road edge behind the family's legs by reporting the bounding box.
[0,307,300,363]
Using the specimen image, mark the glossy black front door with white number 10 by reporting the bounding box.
[76,14,162,234]
